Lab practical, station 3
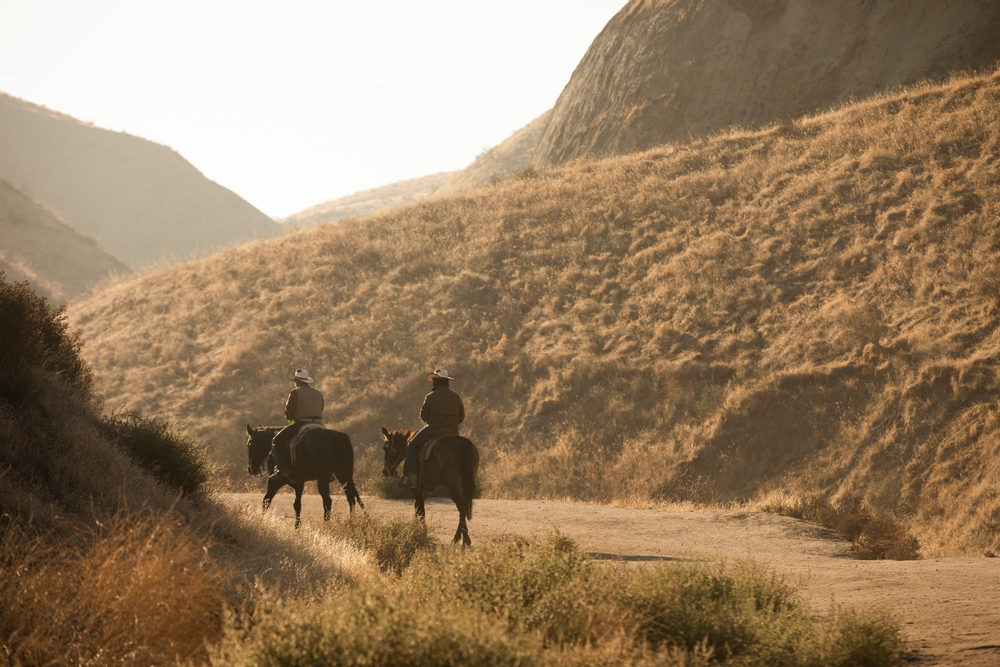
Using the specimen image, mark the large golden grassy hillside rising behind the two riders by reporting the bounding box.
[70,71,1000,555]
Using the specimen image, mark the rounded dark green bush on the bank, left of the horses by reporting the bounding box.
[101,412,212,493]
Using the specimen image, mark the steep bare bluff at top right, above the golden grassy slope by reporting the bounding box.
[532,0,1000,167]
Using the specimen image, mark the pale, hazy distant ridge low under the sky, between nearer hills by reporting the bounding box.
[280,171,458,227]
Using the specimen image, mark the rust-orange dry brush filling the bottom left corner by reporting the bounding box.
[0,512,223,666]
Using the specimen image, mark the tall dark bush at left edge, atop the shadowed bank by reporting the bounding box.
[0,271,93,404]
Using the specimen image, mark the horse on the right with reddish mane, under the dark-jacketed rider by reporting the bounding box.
[382,427,479,547]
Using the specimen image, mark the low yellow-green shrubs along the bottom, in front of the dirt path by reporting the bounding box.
[221,533,902,667]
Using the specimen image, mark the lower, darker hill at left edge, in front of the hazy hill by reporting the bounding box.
[0,180,131,303]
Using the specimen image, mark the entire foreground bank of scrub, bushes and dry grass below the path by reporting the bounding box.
[0,274,903,666]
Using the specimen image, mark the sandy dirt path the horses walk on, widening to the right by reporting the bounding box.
[227,492,1000,667]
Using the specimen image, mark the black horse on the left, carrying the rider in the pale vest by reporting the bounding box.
[247,424,365,528]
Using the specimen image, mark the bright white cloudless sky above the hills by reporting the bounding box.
[0,0,625,218]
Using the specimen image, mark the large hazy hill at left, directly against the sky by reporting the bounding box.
[0,93,279,269]
